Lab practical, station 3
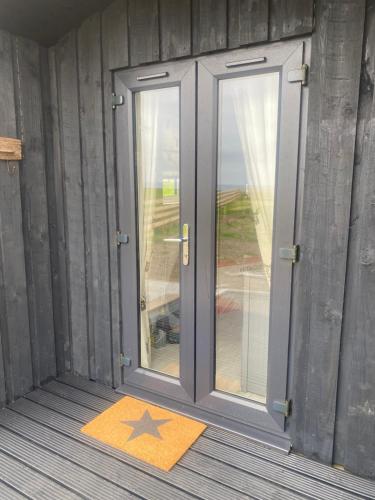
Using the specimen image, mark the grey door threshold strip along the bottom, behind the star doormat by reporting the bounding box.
[116,384,292,455]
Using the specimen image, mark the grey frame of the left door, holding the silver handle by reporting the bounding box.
[114,60,196,402]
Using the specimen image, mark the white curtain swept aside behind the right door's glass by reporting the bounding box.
[231,73,278,285]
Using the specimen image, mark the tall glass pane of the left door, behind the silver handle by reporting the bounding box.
[135,87,180,377]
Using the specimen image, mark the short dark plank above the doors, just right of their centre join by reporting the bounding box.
[193,0,227,54]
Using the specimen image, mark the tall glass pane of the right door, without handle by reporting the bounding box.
[216,73,279,403]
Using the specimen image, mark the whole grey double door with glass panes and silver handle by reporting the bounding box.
[115,42,306,447]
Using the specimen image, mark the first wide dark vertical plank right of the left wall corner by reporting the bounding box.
[56,32,89,375]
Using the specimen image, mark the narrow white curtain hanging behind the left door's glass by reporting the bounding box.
[136,91,160,368]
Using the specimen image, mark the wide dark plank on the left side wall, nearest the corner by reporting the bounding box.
[14,38,56,385]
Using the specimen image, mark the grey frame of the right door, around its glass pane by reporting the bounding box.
[196,41,308,446]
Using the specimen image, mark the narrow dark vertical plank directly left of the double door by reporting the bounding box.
[102,10,122,387]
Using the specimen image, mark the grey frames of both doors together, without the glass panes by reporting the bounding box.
[114,39,310,450]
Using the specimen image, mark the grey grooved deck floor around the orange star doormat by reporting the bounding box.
[0,377,375,500]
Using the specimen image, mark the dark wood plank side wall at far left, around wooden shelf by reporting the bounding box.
[0,31,56,404]
